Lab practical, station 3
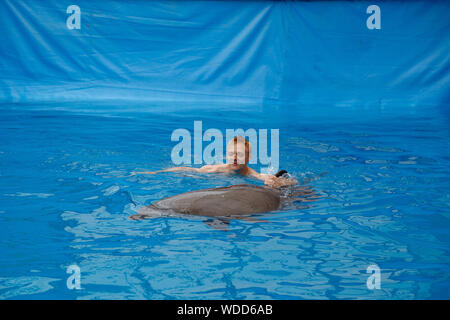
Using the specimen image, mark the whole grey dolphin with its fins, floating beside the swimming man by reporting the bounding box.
[130,180,317,231]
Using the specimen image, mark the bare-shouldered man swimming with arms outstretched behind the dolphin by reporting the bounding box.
[135,136,297,188]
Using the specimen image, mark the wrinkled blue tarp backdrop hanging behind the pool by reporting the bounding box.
[0,0,450,107]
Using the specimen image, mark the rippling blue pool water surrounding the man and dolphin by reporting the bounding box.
[0,105,450,299]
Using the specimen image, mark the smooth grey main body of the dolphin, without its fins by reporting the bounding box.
[130,184,281,220]
